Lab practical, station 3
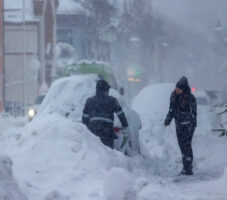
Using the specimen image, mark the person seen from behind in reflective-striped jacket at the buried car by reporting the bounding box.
[82,80,128,148]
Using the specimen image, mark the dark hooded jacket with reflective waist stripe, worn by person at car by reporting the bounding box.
[82,81,128,130]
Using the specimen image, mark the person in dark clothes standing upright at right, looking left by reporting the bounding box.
[164,77,197,175]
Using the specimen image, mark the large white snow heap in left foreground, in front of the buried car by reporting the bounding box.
[0,110,145,200]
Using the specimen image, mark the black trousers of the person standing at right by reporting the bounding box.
[176,125,195,170]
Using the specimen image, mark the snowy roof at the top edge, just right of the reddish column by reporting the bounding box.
[57,0,88,14]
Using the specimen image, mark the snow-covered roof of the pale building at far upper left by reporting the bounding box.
[4,0,36,23]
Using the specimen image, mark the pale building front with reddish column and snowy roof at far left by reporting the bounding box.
[4,0,58,114]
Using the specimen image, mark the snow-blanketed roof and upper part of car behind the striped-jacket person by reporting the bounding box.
[37,74,126,121]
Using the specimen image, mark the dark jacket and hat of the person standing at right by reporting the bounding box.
[165,77,197,127]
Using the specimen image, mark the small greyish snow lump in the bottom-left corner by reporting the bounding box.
[0,155,27,200]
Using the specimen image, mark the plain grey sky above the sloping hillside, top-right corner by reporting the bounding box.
[152,0,227,35]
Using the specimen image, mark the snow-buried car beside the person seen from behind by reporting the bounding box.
[38,74,142,155]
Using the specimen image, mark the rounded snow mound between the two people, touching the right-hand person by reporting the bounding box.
[132,83,180,176]
